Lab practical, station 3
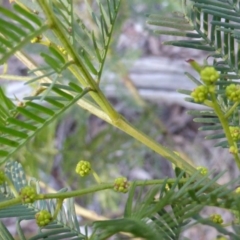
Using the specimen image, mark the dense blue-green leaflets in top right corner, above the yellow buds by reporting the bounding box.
[148,0,239,67]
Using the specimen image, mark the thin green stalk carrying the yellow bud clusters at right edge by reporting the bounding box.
[211,93,240,169]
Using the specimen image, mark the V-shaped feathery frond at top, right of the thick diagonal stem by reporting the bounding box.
[16,0,121,82]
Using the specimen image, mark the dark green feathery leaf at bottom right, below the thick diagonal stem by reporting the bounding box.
[93,172,240,240]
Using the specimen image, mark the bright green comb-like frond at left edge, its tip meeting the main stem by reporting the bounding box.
[0,82,89,164]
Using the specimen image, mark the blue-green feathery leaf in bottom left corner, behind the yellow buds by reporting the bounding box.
[0,161,85,240]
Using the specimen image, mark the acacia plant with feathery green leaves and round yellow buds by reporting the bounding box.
[0,0,240,240]
